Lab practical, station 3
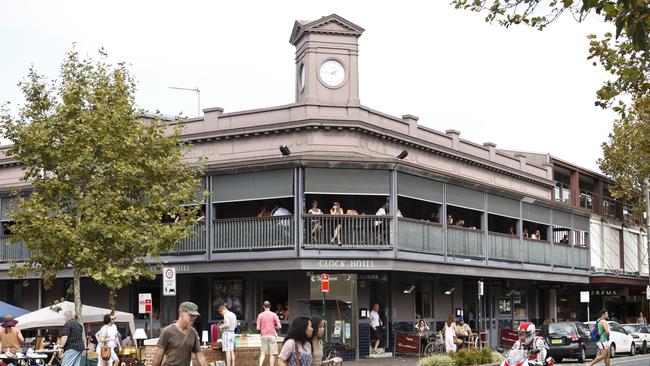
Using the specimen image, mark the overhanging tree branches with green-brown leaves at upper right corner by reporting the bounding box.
[452,0,650,214]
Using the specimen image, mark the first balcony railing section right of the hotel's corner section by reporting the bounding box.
[397,217,445,255]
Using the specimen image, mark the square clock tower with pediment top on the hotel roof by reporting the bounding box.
[289,14,364,106]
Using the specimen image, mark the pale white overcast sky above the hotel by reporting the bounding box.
[0,0,615,171]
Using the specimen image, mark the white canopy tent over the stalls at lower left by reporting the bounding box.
[16,301,135,334]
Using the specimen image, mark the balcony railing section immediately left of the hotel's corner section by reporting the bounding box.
[212,216,295,251]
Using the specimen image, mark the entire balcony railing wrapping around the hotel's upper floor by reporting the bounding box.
[0,215,590,270]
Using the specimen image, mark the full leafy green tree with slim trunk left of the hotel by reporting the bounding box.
[0,49,203,320]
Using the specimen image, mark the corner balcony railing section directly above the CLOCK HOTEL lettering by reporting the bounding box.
[303,215,390,247]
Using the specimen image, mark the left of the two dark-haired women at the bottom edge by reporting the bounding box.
[278,316,314,366]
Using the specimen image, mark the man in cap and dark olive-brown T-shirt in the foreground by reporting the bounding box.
[153,301,208,366]
